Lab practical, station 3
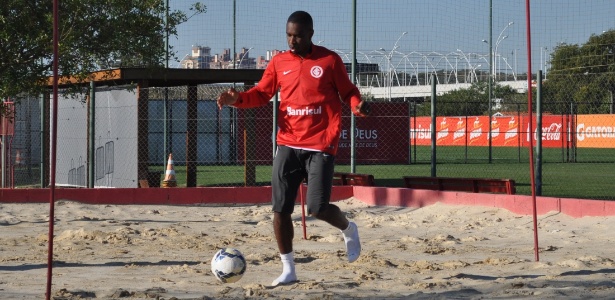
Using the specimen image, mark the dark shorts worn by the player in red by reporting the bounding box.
[271,146,335,214]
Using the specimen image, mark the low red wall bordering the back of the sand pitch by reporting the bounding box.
[0,186,615,218]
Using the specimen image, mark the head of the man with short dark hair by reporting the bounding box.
[286,11,314,56]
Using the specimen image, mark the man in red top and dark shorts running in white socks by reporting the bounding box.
[218,11,369,286]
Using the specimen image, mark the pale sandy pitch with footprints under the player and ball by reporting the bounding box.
[0,198,615,300]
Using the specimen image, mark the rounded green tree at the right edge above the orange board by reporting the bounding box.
[543,30,615,113]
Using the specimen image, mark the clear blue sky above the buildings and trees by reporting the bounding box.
[170,0,615,73]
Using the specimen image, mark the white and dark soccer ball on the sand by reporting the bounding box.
[211,248,246,283]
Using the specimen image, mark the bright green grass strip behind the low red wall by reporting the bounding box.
[156,151,615,200]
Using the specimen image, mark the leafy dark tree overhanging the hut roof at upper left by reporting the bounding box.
[0,0,207,103]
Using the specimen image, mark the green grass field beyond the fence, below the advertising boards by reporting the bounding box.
[152,147,615,200]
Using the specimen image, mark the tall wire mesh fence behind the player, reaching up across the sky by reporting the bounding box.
[5,0,615,199]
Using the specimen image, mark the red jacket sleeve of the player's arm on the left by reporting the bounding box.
[233,61,279,108]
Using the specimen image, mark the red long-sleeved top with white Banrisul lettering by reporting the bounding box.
[233,45,361,155]
